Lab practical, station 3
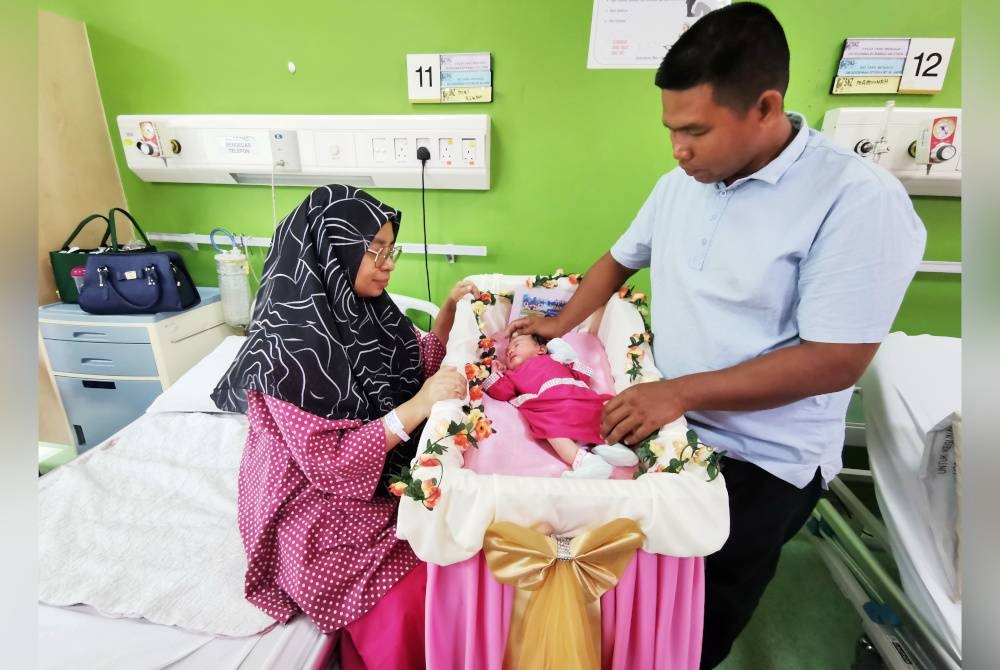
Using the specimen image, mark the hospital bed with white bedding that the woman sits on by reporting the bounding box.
[38,295,438,670]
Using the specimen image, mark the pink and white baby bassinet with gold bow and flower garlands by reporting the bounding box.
[395,272,729,670]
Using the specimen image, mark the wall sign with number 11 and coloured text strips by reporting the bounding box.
[406,51,493,102]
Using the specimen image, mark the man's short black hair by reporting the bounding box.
[656,2,789,113]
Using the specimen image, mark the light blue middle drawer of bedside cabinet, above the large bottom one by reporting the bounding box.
[45,340,158,377]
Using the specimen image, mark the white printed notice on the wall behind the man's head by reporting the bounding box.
[587,0,730,69]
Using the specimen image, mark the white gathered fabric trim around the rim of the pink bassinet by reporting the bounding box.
[397,274,729,565]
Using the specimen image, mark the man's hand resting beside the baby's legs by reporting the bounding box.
[601,380,686,446]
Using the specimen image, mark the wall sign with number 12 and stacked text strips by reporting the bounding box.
[830,37,955,95]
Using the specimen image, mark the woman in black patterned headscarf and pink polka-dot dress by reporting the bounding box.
[213,185,475,669]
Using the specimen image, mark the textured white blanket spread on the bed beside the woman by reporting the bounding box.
[38,413,274,636]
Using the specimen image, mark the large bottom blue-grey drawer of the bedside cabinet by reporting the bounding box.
[55,375,162,452]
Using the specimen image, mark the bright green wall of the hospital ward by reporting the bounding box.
[40,0,961,335]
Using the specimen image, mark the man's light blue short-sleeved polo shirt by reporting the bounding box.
[611,114,926,488]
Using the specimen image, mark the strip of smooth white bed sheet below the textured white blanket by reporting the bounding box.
[38,605,332,670]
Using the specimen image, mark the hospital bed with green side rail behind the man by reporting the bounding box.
[808,333,962,670]
